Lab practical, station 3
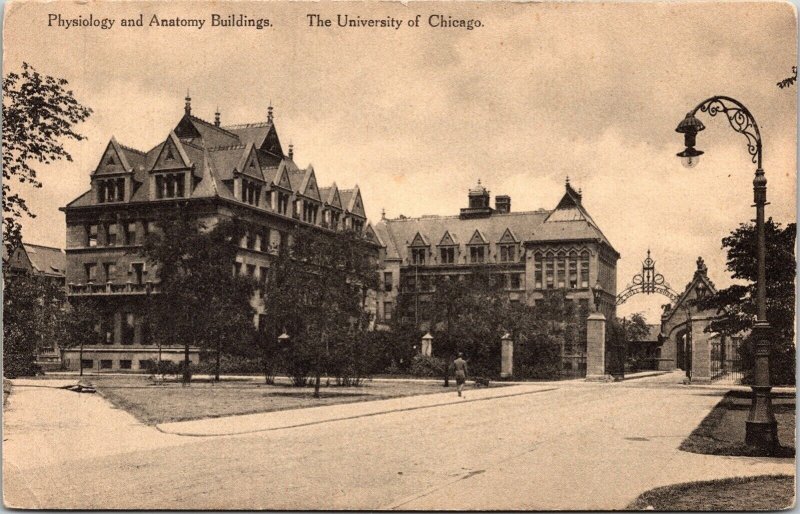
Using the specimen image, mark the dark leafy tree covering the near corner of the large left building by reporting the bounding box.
[144,208,257,383]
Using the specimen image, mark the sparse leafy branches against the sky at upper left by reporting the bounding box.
[3,63,92,254]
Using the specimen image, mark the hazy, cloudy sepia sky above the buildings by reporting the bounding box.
[3,1,797,322]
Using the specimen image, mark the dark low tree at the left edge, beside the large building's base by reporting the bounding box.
[3,274,64,378]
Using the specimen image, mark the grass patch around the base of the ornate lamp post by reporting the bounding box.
[680,391,795,458]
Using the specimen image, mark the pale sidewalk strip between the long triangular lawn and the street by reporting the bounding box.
[156,383,557,437]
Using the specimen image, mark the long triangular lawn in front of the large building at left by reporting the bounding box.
[86,375,501,425]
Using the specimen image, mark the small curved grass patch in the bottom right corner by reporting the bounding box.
[627,475,794,512]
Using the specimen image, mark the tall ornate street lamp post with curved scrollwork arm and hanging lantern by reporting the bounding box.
[675,96,778,449]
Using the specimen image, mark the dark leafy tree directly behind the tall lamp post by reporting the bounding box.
[698,218,796,384]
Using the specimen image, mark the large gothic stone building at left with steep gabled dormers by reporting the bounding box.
[62,97,374,370]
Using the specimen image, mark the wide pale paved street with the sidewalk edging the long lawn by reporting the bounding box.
[3,377,794,510]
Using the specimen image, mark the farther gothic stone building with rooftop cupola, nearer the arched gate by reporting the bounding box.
[375,181,619,323]
